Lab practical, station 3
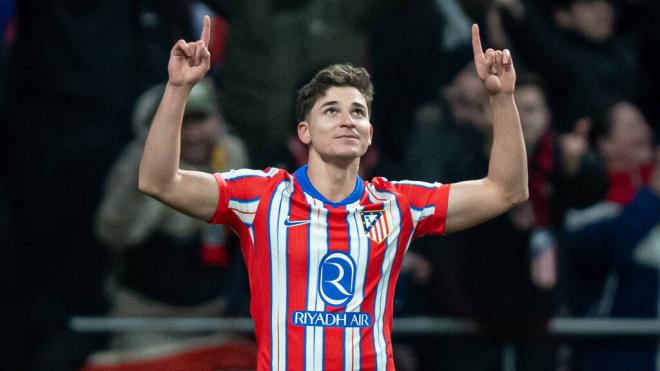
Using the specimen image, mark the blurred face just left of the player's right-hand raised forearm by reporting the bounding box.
[445,64,491,133]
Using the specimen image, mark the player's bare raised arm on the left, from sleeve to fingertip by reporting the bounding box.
[138,16,219,221]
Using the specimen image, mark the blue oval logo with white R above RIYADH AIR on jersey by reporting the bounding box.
[319,251,356,307]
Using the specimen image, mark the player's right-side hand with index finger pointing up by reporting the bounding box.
[472,24,516,96]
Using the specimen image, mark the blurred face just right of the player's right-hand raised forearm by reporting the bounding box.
[515,84,550,152]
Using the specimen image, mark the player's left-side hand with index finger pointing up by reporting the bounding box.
[167,15,211,87]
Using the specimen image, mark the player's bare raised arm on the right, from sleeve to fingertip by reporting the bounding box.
[445,25,529,233]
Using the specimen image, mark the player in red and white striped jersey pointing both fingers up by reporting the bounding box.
[139,18,527,370]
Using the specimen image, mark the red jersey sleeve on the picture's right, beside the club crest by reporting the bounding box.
[393,180,451,238]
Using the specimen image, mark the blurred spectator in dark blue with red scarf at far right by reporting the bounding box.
[566,101,660,371]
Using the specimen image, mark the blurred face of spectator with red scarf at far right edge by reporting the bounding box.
[598,102,653,170]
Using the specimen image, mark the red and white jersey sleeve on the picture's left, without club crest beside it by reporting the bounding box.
[210,168,286,227]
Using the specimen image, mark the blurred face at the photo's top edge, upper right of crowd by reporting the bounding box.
[555,0,615,41]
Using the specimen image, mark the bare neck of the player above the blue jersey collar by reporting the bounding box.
[307,154,360,202]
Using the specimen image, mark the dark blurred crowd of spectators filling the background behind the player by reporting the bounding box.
[0,0,660,371]
